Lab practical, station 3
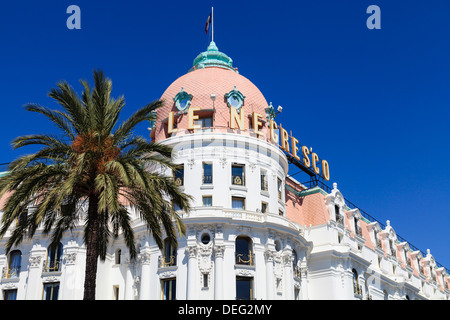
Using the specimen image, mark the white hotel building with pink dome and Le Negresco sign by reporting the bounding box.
[0,42,450,300]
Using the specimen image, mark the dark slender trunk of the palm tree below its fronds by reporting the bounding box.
[83,195,100,300]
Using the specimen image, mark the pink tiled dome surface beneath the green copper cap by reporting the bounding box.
[152,67,268,141]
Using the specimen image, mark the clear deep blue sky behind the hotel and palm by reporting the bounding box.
[0,0,450,268]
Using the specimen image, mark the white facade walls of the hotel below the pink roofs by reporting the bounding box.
[0,132,449,300]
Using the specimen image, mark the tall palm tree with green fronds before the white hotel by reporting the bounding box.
[0,71,191,300]
